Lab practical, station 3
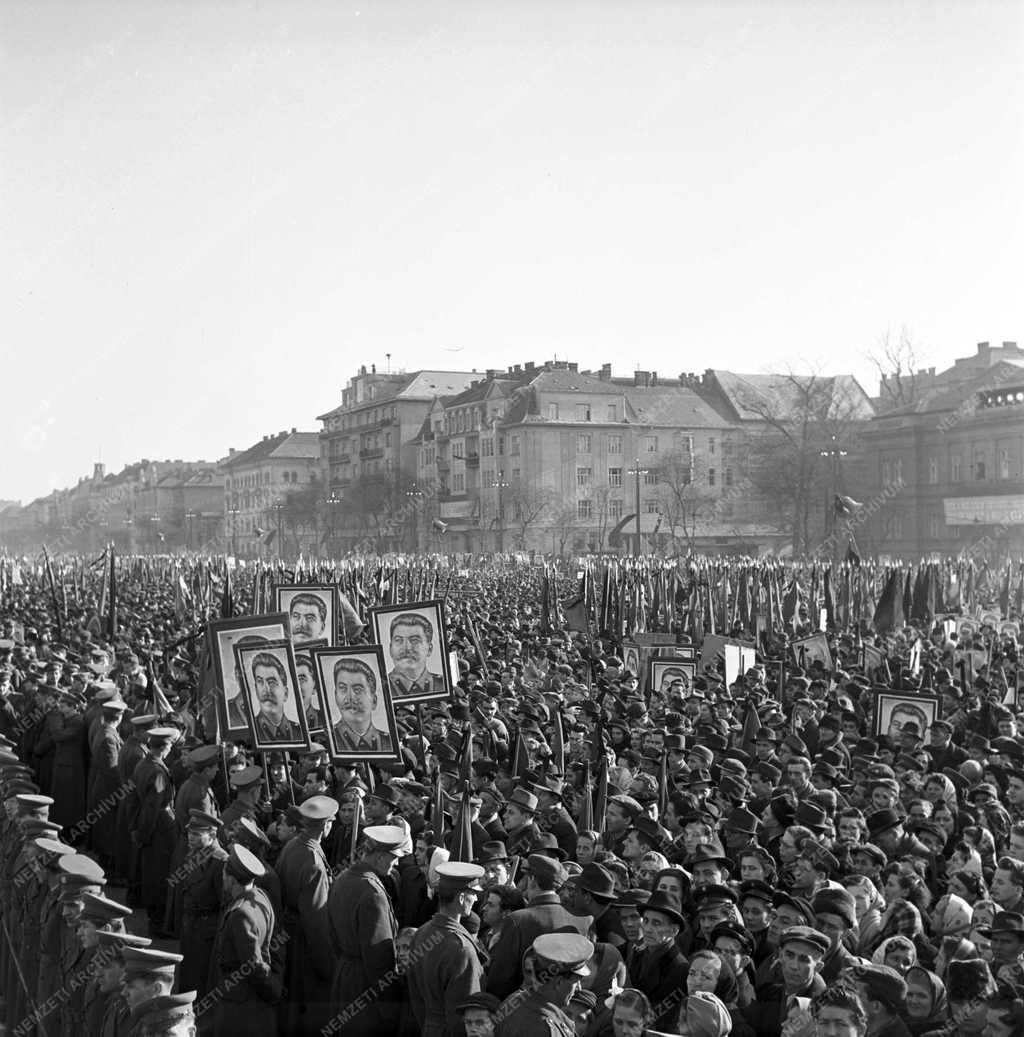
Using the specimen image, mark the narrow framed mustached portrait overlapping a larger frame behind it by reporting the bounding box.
[234,638,309,752]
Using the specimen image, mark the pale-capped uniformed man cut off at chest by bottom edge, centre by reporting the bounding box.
[496,932,594,1037]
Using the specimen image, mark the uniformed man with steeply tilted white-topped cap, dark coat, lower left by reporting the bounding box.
[212,843,281,1037]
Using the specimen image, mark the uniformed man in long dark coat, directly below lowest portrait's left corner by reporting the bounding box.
[277,795,336,1035]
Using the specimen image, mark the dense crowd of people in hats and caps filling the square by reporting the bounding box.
[0,564,1024,1037]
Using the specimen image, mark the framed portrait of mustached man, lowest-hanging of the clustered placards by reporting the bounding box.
[312,645,400,762]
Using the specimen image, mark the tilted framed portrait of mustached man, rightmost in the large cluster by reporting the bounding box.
[371,601,453,705]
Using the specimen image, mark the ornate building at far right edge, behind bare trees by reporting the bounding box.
[864,342,1024,560]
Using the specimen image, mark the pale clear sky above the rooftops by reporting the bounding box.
[0,0,1024,500]
